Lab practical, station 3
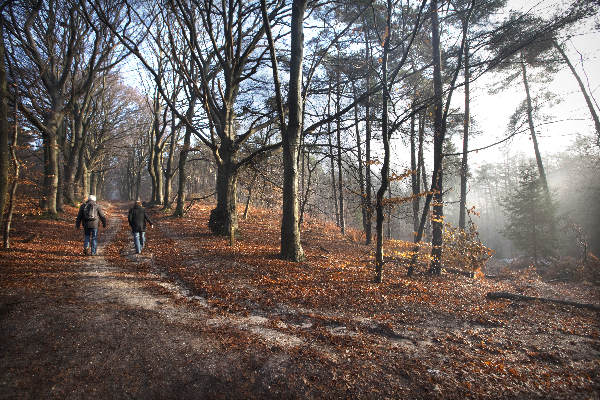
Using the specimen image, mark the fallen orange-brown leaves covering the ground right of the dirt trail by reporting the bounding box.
[143,205,600,398]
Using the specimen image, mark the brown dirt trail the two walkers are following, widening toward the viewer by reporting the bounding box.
[0,217,280,399]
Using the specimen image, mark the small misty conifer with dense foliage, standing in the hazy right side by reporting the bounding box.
[502,162,556,263]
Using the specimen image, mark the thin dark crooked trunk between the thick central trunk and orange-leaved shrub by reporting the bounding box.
[375,0,392,283]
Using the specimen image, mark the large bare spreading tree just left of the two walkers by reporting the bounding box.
[6,0,120,215]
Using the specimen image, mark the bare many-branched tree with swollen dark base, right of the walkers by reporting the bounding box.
[89,0,287,235]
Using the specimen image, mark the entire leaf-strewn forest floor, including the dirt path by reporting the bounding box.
[0,204,600,399]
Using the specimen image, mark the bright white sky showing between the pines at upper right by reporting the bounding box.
[462,0,600,167]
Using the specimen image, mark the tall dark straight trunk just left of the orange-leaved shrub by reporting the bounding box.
[429,0,445,275]
